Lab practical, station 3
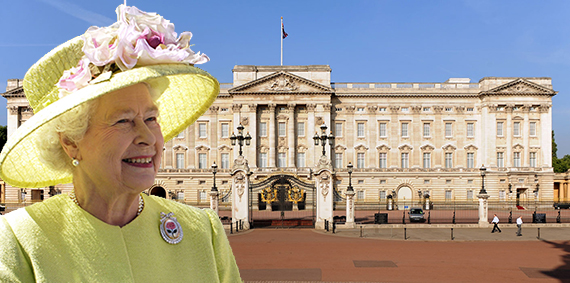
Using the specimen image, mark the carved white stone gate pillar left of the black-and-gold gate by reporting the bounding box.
[232,156,249,230]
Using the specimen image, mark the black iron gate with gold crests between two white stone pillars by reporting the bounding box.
[249,174,315,228]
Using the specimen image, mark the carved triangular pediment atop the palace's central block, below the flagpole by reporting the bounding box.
[228,71,333,95]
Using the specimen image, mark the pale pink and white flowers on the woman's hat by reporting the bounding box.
[57,5,210,96]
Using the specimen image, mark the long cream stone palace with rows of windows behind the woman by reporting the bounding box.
[2,65,560,210]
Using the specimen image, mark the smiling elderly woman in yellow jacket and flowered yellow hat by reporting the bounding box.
[0,5,241,282]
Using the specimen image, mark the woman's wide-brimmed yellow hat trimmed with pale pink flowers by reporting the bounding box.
[0,5,220,188]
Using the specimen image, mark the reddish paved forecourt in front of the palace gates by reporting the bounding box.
[229,229,570,282]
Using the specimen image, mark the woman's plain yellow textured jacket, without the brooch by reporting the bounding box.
[0,195,241,282]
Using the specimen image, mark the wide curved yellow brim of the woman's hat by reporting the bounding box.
[0,64,220,188]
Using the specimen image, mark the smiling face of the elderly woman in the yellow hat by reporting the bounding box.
[77,84,164,193]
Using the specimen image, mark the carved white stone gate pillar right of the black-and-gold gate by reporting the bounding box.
[314,159,334,230]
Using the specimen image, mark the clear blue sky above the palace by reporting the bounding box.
[0,0,570,157]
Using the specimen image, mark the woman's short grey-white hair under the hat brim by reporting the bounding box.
[36,82,160,173]
